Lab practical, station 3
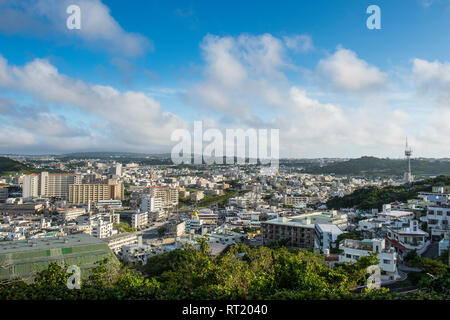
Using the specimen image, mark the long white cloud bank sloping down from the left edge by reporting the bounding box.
[0,54,185,151]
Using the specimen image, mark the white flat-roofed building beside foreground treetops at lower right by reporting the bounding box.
[339,239,400,281]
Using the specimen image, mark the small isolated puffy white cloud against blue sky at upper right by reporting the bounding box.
[317,47,388,93]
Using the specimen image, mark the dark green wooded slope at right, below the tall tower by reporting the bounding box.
[327,176,450,210]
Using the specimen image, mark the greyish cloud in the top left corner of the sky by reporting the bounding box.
[0,0,153,56]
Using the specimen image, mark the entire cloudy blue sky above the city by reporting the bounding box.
[0,0,450,157]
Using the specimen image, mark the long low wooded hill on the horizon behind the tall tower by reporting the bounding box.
[304,157,450,176]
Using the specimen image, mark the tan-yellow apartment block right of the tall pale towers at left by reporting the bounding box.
[69,179,125,204]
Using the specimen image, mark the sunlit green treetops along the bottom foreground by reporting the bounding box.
[0,239,450,300]
